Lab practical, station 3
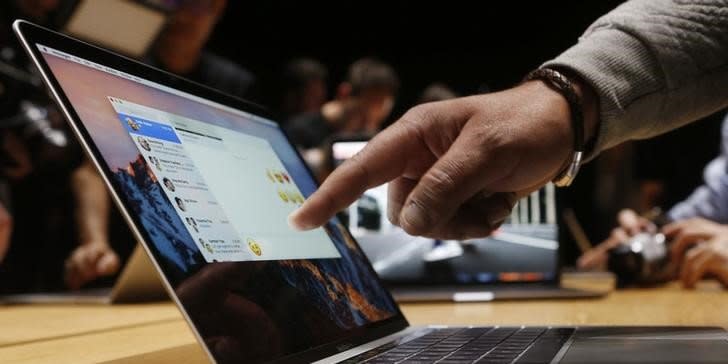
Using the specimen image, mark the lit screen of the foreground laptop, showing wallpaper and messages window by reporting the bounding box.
[36,45,402,363]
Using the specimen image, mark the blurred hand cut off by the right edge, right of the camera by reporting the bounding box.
[680,234,728,288]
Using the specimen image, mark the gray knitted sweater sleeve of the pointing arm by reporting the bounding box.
[544,0,728,157]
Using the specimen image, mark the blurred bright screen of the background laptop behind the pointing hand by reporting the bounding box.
[329,137,558,287]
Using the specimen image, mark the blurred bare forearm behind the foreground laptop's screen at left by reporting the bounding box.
[71,161,110,244]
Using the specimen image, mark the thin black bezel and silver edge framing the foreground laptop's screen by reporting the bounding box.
[13,20,409,362]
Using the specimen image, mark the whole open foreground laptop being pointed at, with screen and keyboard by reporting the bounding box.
[14,21,728,364]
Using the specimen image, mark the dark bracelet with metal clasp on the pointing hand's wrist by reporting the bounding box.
[524,68,584,187]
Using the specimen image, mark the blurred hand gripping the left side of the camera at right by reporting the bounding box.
[576,209,657,270]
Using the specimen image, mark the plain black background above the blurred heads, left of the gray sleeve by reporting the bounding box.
[208,0,621,117]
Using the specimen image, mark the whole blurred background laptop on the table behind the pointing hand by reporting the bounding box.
[326,135,614,302]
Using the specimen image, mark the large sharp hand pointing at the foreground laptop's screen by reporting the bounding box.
[290,81,596,239]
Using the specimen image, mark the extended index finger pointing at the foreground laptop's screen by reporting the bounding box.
[289,122,422,230]
